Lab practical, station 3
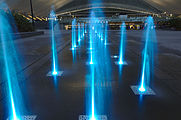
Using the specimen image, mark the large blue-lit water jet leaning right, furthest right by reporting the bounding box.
[139,16,156,92]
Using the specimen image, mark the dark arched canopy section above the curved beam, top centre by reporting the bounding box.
[57,0,161,15]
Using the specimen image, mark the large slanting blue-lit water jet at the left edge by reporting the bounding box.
[0,2,36,120]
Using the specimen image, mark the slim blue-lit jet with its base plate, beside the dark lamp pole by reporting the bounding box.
[47,10,63,77]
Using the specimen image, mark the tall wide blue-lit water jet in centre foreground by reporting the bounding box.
[86,0,112,120]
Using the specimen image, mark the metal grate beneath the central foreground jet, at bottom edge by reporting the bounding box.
[79,115,107,120]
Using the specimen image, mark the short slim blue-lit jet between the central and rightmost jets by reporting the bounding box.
[118,22,126,65]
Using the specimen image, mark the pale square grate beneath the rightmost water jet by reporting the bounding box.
[131,86,156,95]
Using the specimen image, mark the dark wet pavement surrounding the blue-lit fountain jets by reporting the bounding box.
[0,31,181,120]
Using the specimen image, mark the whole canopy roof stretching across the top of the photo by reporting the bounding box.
[4,0,181,16]
